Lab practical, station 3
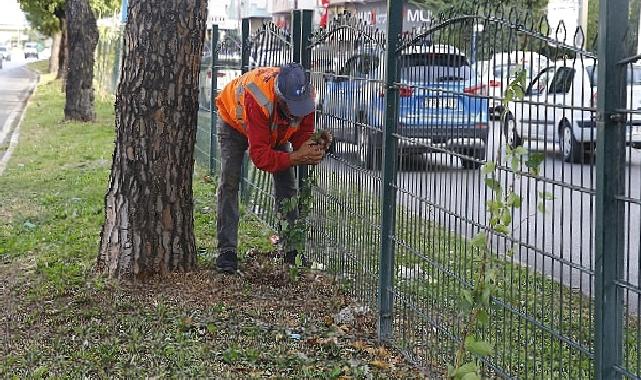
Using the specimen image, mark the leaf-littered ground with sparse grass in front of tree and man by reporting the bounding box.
[0,252,425,379]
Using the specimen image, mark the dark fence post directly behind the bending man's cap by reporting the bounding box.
[292,9,314,189]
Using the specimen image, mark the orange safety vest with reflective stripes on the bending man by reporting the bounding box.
[216,67,300,146]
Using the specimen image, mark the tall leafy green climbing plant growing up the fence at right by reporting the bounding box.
[448,70,553,380]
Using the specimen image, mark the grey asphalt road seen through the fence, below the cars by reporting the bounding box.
[324,123,641,310]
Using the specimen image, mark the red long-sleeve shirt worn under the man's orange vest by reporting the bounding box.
[245,93,314,173]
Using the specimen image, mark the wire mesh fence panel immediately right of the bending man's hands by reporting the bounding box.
[309,14,385,305]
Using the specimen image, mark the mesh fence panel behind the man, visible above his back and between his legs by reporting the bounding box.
[244,22,292,229]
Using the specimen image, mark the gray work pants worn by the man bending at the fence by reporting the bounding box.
[216,120,298,253]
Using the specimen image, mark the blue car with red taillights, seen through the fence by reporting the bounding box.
[322,45,488,169]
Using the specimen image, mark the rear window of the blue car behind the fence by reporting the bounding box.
[400,53,474,83]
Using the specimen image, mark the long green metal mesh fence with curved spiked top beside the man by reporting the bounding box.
[197,1,641,379]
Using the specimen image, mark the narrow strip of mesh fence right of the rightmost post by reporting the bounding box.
[612,52,641,378]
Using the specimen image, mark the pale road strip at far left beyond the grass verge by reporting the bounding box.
[0,56,37,165]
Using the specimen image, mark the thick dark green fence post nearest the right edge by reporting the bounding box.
[594,0,629,379]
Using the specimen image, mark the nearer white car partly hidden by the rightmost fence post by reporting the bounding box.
[503,59,641,163]
